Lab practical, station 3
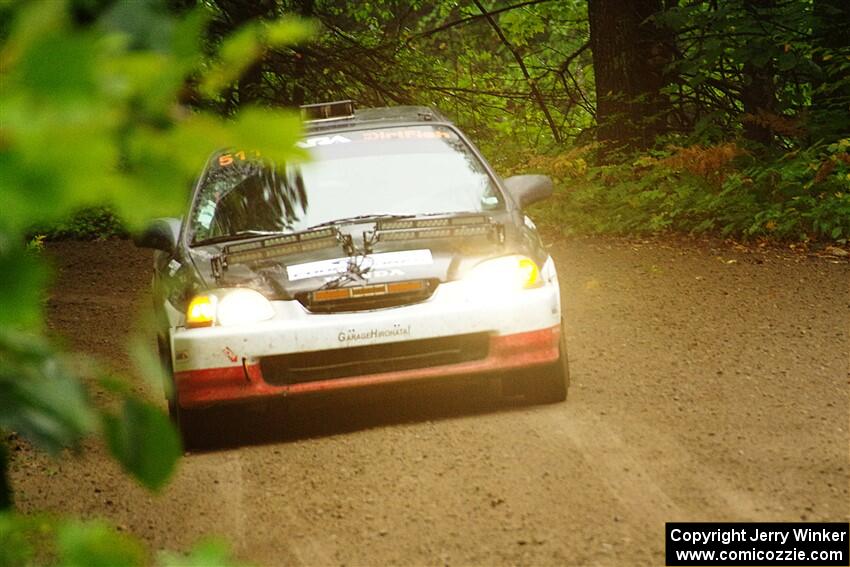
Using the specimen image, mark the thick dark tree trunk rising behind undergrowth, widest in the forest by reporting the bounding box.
[588,0,673,149]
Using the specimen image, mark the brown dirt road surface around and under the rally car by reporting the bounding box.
[12,239,850,565]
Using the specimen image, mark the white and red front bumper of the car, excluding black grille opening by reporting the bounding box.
[171,280,561,407]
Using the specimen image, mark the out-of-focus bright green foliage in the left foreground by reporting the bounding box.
[0,0,309,565]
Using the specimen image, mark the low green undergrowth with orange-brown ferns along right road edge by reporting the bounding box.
[516,138,850,244]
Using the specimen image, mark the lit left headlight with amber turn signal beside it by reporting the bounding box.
[186,288,274,327]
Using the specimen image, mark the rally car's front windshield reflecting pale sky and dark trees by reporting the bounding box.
[191,125,504,243]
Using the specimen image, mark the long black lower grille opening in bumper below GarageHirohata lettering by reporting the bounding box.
[260,333,490,385]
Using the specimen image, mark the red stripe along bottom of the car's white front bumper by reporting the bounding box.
[174,326,561,407]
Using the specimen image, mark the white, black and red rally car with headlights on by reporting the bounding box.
[137,101,569,440]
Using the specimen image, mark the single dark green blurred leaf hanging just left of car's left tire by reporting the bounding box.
[103,397,182,490]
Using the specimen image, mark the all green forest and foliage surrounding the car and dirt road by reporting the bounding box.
[0,0,850,564]
